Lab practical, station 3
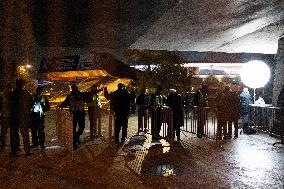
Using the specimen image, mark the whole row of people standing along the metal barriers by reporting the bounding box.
[0,79,270,156]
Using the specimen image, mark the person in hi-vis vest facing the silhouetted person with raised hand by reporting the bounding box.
[83,84,103,140]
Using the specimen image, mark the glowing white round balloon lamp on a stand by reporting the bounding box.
[240,60,270,89]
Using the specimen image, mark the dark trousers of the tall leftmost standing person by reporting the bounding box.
[10,123,30,155]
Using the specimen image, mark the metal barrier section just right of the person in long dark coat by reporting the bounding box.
[181,106,217,139]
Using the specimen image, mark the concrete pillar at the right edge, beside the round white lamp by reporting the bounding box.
[272,35,284,106]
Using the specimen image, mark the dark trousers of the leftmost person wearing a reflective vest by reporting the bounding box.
[31,113,45,147]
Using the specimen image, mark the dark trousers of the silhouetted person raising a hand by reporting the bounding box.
[114,114,128,143]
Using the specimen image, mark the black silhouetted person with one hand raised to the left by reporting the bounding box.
[104,83,131,144]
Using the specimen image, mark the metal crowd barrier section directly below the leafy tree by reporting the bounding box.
[137,106,174,141]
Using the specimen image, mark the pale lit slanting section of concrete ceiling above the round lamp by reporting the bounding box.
[130,0,284,54]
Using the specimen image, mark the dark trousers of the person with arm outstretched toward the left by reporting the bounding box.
[72,110,85,145]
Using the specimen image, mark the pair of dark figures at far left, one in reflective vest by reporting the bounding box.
[1,79,50,157]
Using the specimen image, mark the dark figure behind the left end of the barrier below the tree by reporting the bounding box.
[136,88,149,131]
